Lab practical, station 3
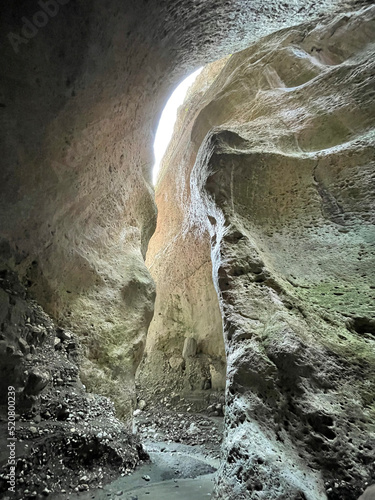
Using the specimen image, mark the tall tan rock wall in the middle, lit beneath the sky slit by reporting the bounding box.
[137,60,226,407]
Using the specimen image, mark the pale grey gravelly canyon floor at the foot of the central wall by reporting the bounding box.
[49,410,223,500]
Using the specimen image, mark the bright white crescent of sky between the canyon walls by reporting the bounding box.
[152,68,203,185]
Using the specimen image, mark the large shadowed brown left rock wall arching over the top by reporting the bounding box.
[0,0,346,416]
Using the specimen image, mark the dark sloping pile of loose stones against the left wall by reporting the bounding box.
[0,271,148,499]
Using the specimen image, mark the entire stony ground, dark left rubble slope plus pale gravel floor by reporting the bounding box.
[0,272,224,500]
